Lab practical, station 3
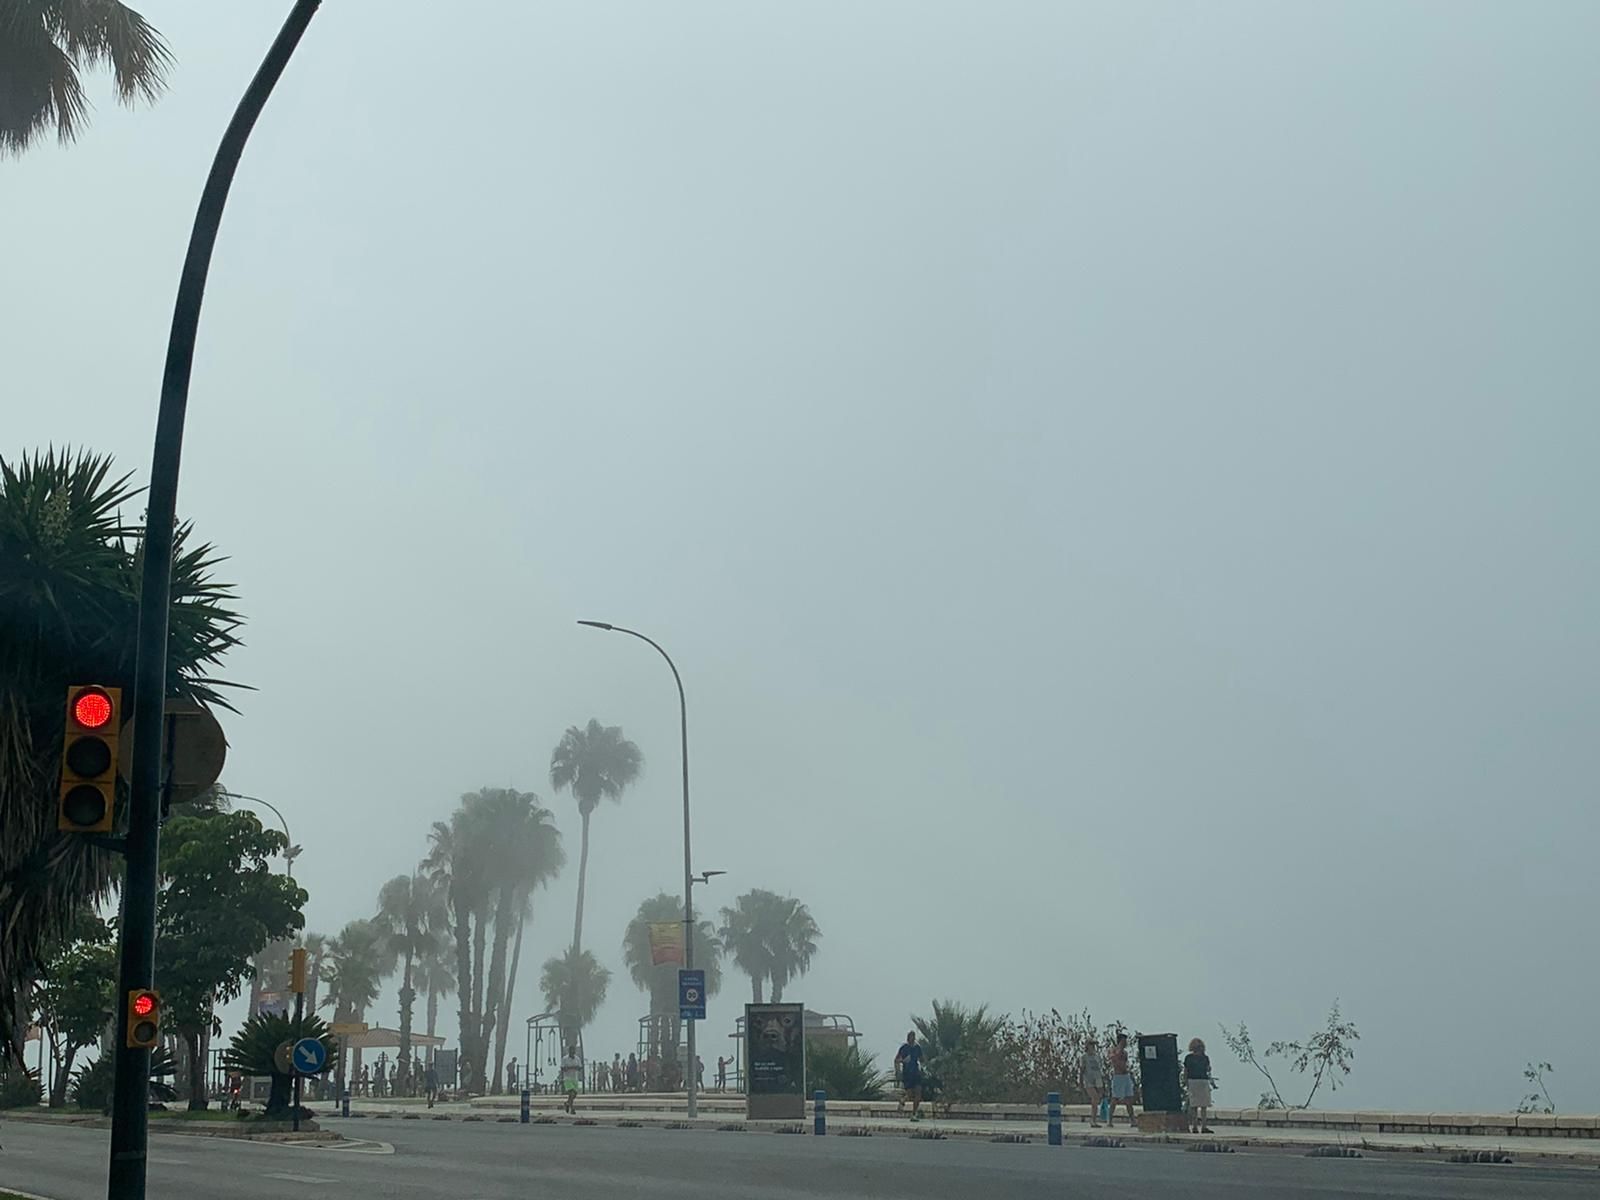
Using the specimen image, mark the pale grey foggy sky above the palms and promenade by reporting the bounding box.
[0,0,1600,1112]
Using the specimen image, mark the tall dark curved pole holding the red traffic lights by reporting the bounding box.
[106,9,320,1200]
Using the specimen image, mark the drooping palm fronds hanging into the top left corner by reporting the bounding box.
[0,0,173,154]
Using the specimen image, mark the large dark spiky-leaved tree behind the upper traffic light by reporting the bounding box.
[0,454,240,1062]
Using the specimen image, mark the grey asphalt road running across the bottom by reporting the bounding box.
[0,1120,1600,1200]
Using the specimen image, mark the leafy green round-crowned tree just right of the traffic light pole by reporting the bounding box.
[155,813,306,1109]
